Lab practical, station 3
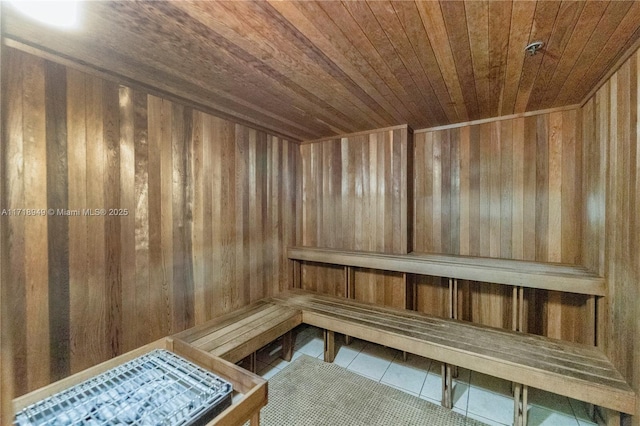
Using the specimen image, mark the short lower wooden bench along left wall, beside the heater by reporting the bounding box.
[173,300,302,372]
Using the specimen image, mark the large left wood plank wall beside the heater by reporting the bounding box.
[1,49,299,395]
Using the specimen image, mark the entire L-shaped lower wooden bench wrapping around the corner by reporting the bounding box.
[173,290,636,425]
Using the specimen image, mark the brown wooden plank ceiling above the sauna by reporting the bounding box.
[3,1,640,139]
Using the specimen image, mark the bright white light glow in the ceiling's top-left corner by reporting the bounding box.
[10,0,78,28]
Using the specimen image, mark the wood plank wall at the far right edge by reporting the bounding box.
[582,52,640,426]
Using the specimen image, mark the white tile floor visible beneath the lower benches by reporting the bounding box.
[251,325,595,426]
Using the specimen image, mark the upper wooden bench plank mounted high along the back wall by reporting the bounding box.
[288,247,606,296]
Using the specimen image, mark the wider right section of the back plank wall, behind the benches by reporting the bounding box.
[414,109,594,343]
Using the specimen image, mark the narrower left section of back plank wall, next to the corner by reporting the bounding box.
[299,127,411,308]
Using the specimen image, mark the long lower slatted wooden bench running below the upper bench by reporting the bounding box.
[273,290,636,425]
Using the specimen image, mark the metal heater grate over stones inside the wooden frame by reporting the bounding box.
[14,349,232,426]
